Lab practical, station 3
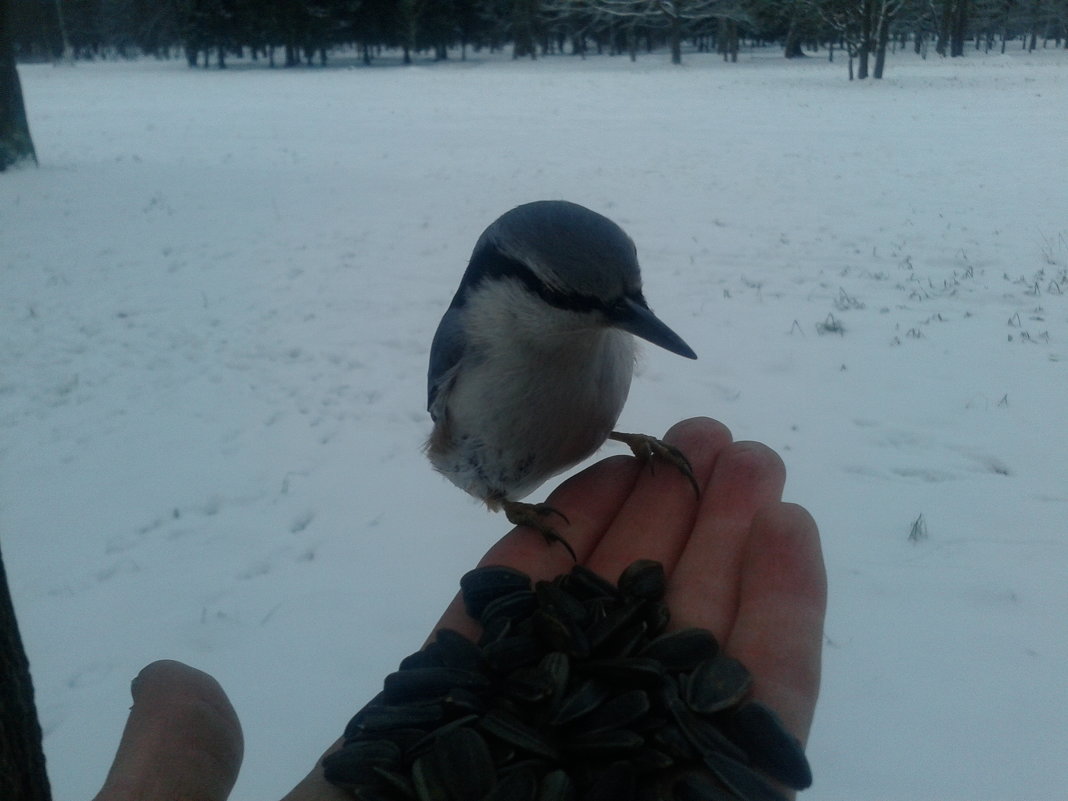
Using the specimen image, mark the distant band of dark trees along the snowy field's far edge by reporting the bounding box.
[10,0,1068,78]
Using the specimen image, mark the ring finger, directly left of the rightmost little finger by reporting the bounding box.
[666,442,786,642]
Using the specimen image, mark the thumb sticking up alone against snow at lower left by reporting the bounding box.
[95,661,244,801]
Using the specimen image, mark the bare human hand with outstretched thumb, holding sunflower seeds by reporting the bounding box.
[96,419,827,801]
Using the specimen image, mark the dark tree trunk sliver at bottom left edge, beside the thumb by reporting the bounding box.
[0,542,51,801]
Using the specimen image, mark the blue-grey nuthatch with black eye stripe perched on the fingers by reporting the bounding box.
[425,200,700,559]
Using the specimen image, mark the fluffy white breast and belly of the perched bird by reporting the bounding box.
[428,280,634,506]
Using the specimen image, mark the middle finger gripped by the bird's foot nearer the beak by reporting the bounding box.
[587,418,731,581]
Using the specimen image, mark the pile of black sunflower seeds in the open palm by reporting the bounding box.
[323,560,812,801]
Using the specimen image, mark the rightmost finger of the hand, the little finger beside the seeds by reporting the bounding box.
[725,503,827,741]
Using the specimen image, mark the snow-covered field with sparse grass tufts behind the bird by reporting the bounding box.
[0,50,1068,801]
